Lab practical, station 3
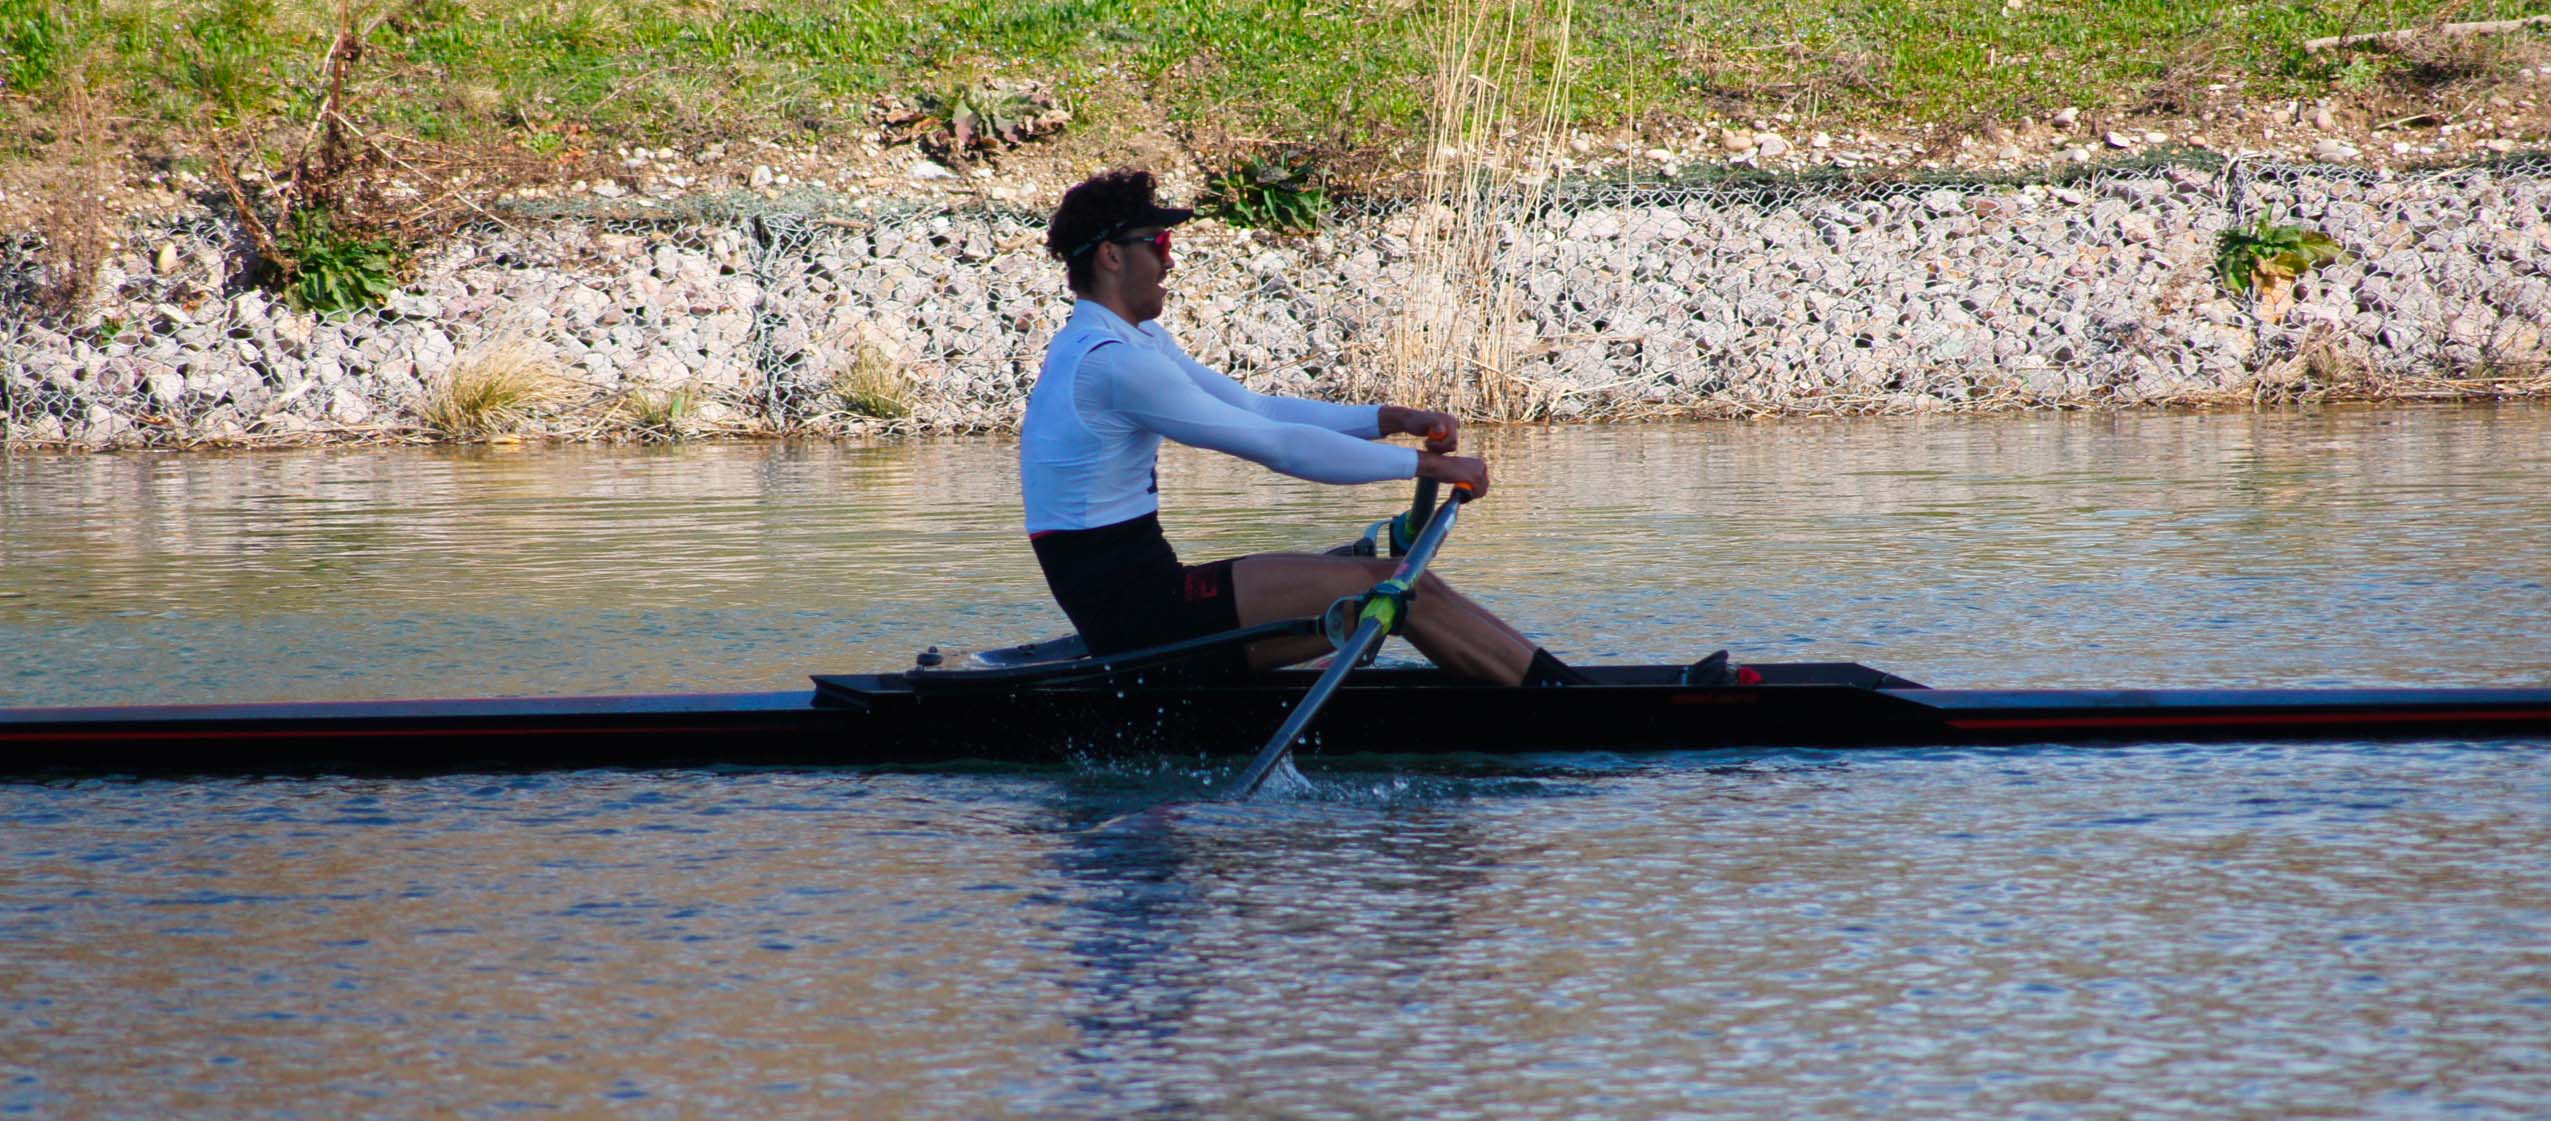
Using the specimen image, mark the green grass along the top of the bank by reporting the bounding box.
[0,0,2541,183]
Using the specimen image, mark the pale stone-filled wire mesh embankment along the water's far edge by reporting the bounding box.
[0,158,2551,447]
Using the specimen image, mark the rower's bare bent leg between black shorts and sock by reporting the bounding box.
[1232,552,1538,684]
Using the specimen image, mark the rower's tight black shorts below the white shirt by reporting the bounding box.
[1031,513,1247,672]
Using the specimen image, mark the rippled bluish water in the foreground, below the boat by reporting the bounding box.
[0,743,2551,1118]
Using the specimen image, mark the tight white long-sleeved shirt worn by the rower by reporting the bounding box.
[1018,299,1418,534]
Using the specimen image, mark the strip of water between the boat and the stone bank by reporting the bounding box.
[0,406,2551,705]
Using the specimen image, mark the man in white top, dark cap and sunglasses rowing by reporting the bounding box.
[1018,169,1584,684]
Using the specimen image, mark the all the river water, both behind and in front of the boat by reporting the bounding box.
[0,406,2551,1118]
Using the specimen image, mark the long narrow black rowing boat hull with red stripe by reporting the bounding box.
[0,664,2551,774]
